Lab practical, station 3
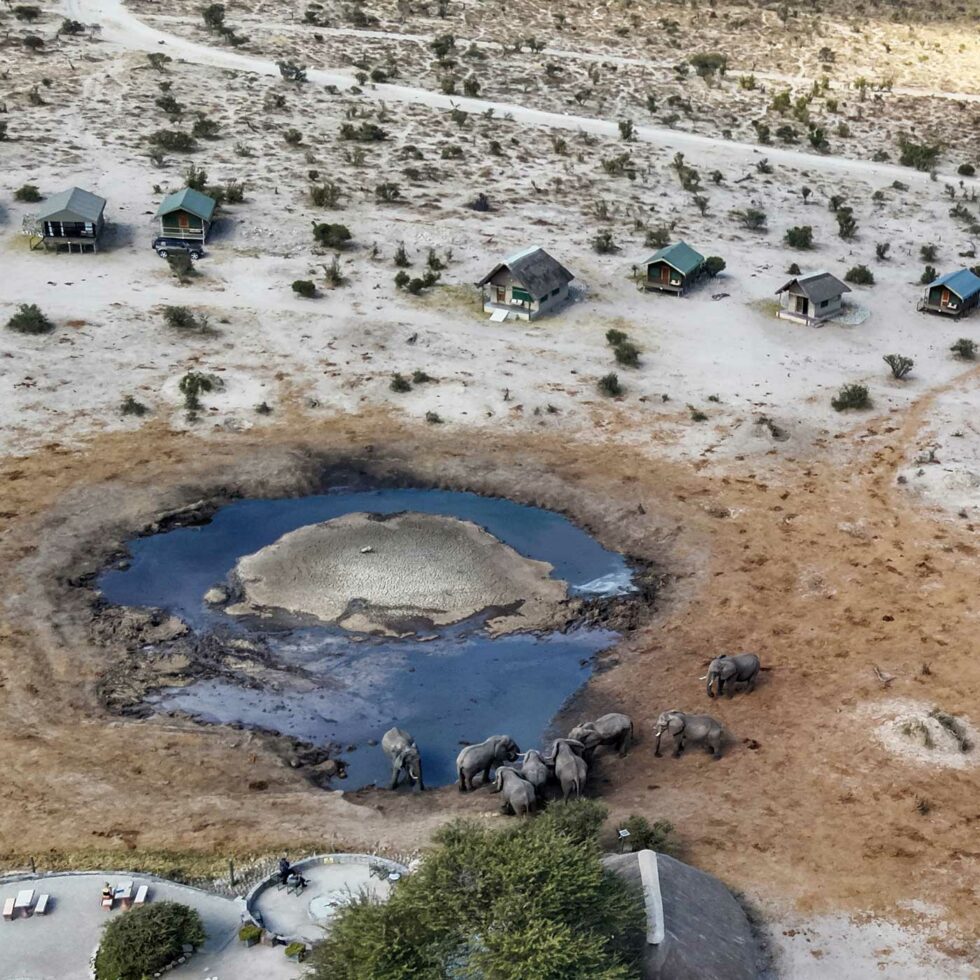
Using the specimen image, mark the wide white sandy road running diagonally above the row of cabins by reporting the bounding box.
[64,0,980,184]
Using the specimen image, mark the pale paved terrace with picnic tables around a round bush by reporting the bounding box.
[0,868,298,980]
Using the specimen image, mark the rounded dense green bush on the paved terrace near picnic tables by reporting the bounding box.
[95,902,206,980]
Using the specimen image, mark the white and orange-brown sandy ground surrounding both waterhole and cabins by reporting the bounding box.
[0,0,980,977]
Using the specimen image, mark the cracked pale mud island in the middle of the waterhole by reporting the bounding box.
[235,513,568,633]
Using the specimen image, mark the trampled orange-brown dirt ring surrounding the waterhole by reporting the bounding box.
[0,402,980,955]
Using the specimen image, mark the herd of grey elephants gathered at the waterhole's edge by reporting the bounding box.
[381,653,761,816]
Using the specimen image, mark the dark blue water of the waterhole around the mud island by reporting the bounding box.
[99,489,630,789]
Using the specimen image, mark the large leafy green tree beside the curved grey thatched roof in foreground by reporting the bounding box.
[310,804,644,980]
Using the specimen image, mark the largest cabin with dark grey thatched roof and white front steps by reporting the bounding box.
[477,246,575,323]
